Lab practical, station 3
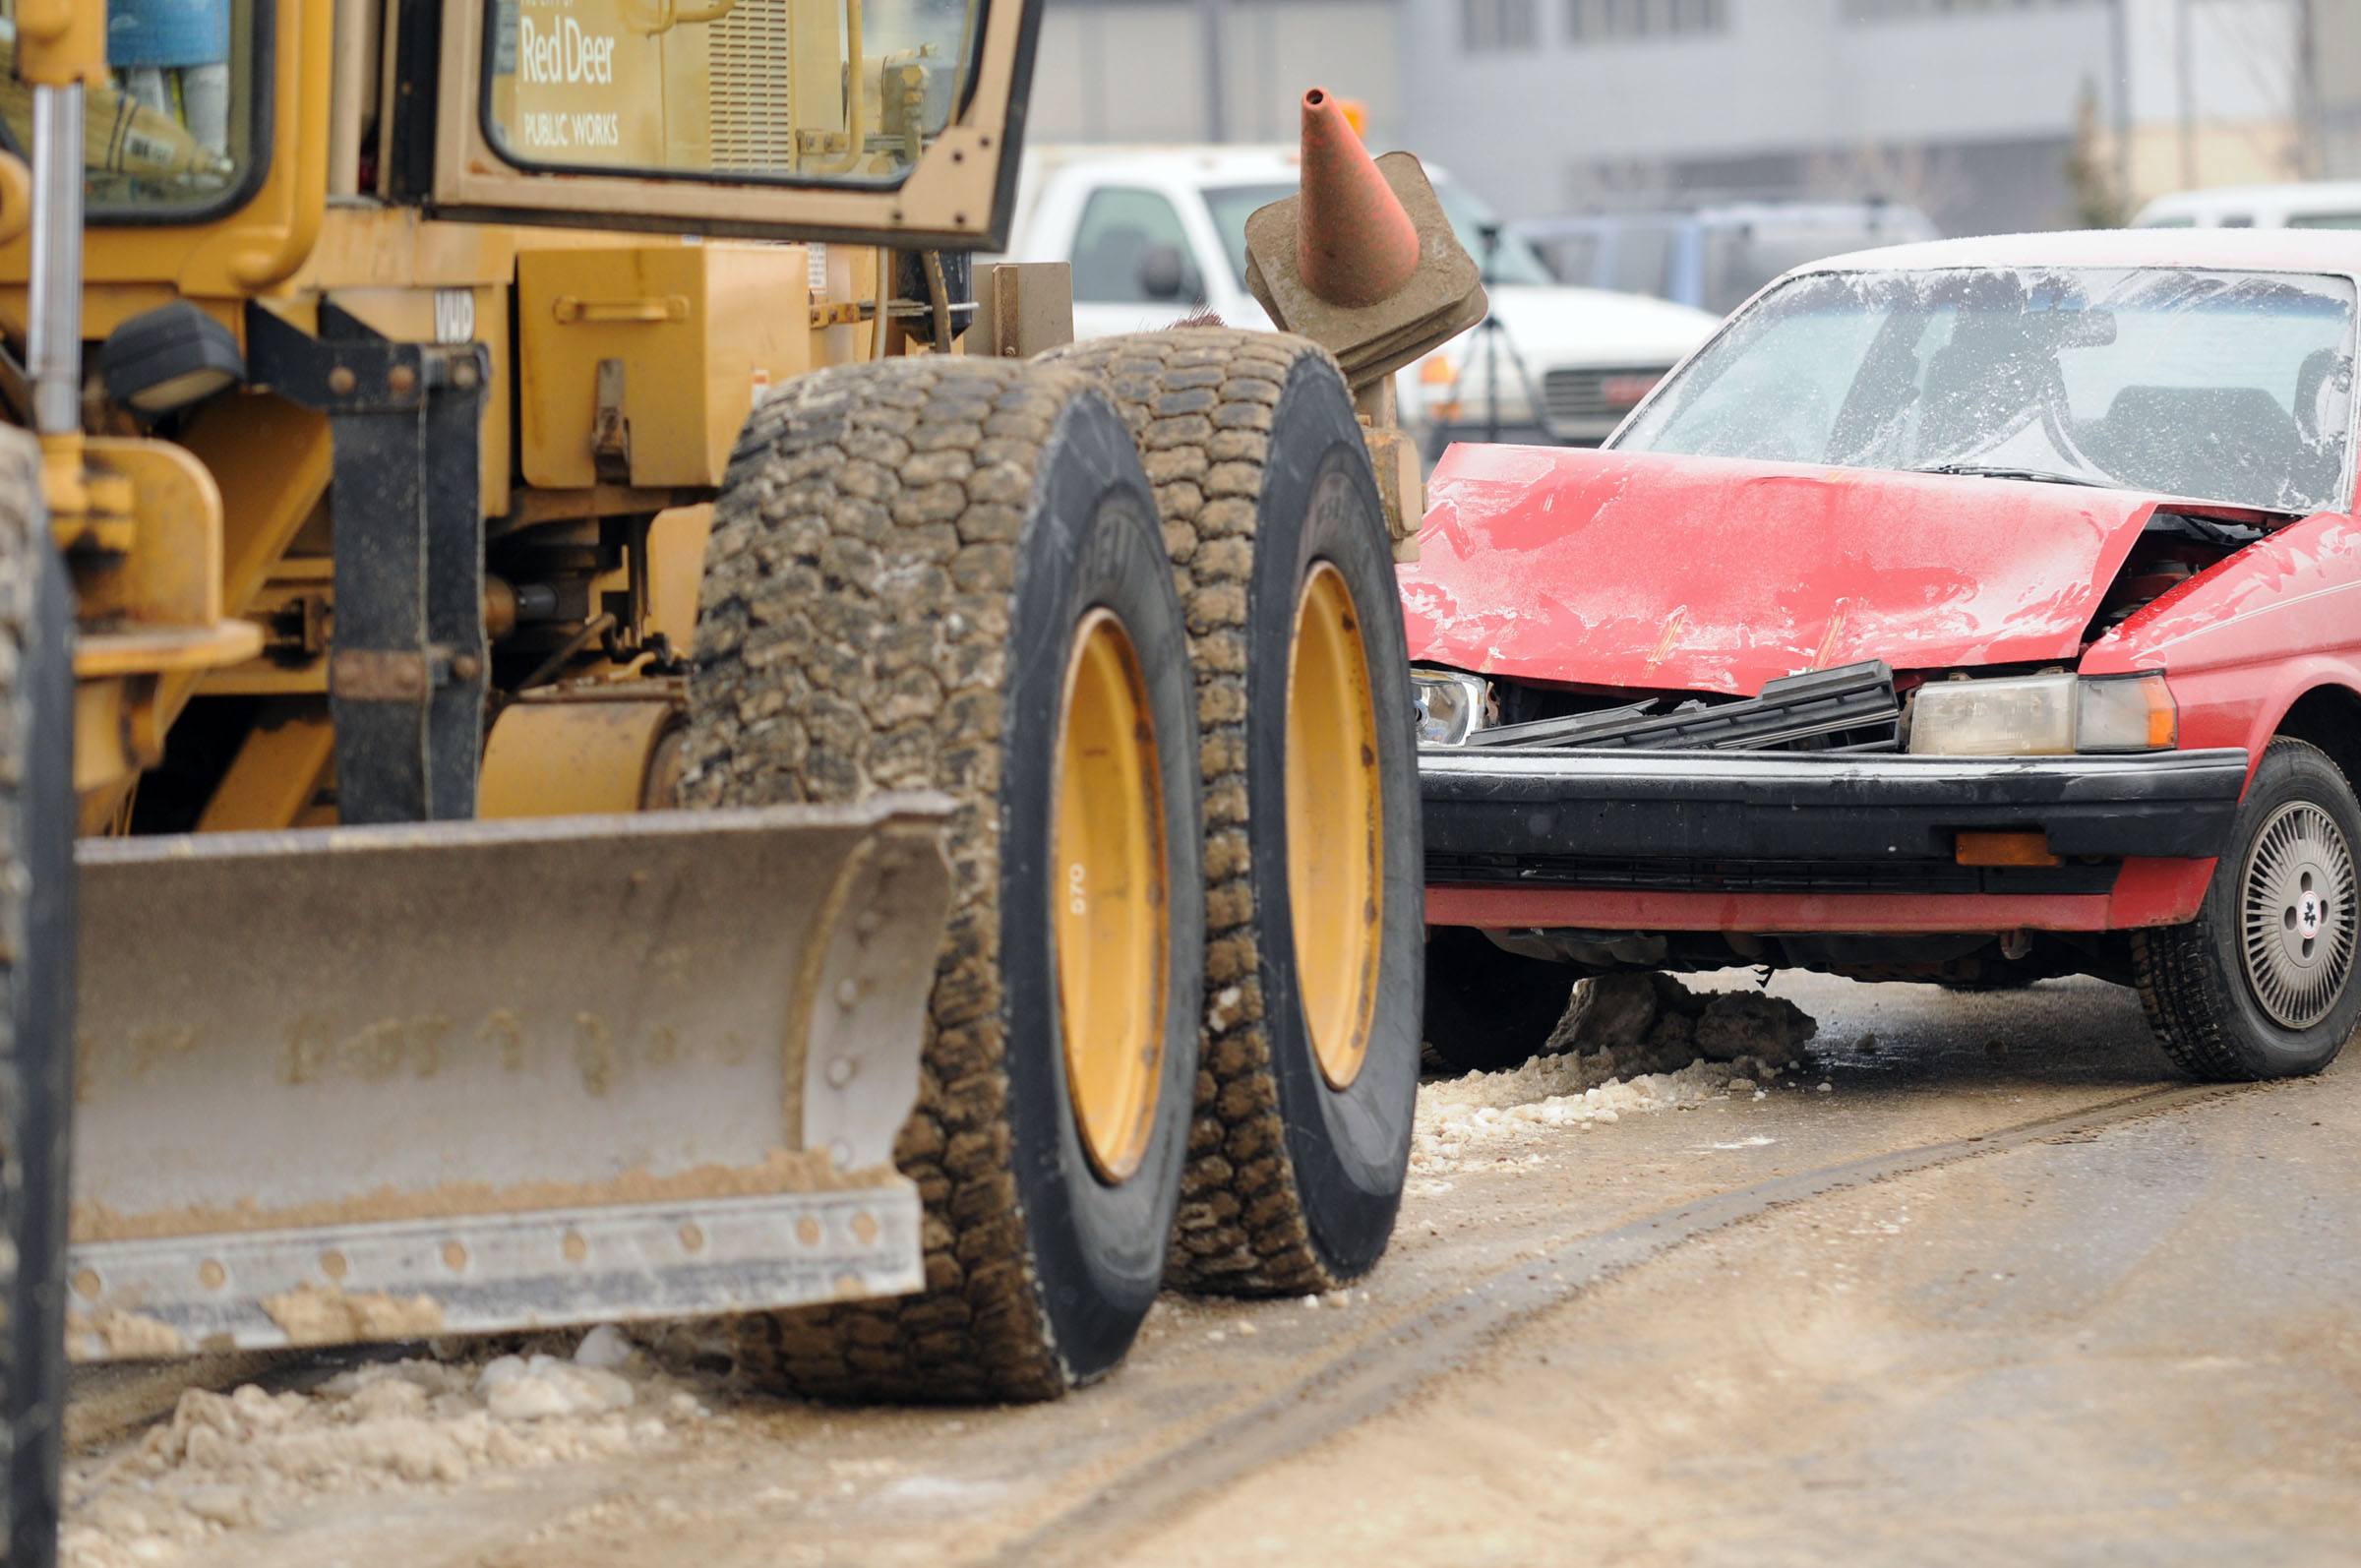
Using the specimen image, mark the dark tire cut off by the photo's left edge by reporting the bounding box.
[0,430,73,1568]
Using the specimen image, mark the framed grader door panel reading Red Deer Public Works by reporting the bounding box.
[435,0,1039,250]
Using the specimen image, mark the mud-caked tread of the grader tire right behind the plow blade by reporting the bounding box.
[683,359,1189,1403]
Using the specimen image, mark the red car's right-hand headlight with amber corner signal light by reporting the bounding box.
[1910,671,2179,755]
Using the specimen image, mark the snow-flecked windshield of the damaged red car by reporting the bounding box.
[1612,267,2354,513]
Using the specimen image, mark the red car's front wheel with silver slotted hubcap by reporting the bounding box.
[2132,739,2361,1081]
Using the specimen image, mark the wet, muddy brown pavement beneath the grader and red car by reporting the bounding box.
[59,973,2361,1568]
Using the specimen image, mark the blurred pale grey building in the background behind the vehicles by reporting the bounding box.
[1032,0,2323,234]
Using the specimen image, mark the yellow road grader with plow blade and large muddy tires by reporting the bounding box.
[0,0,1474,1563]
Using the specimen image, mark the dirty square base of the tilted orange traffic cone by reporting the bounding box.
[1246,153,1485,388]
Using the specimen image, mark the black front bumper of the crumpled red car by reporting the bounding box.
[1419,747,2248,892]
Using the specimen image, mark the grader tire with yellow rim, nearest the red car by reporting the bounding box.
[1049,329,1426,1295]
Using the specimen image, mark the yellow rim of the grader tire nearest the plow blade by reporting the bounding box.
[1051,609,1169,1183]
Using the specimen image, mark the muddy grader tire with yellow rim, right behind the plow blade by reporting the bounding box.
[683,359,1204,1401]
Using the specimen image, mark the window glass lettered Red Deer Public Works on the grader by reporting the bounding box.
[484,0,982,187]
